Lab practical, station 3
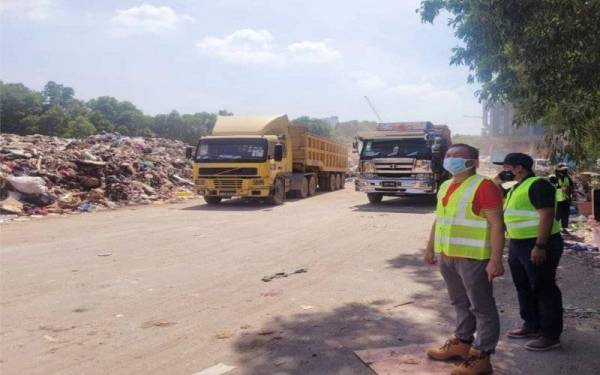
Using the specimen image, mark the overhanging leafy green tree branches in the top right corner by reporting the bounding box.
[420,0,600,161]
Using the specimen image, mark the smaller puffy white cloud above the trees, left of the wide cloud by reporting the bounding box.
[109,3,194,36]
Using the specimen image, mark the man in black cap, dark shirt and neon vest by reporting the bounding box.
[494,153,563,351]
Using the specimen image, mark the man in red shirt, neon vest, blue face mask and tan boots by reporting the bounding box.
[425,144,504,375]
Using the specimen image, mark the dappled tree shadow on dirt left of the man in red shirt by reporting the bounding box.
[233,255,451,375]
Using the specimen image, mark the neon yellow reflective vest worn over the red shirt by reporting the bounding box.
[434,175,491,259]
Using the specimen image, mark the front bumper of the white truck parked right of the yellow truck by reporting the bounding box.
[354,177,435,195]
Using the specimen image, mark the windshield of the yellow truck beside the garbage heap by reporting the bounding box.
[196,138,267,162]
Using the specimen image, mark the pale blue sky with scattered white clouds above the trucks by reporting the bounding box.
[0,0,481,134]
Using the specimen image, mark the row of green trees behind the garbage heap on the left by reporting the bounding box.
[0,81,221,144]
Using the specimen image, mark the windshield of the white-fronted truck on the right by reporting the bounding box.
[361,138,431,160]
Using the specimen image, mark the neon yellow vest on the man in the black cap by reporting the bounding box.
[504,177,560,239]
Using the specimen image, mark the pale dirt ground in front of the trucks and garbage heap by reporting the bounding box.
[0,187,600,375]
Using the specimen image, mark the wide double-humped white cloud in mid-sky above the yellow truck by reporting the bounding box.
[196,29,342,64]
